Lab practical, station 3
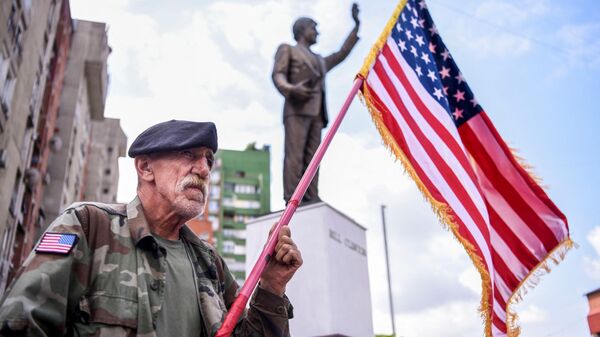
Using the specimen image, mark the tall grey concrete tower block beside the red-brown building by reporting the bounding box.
[43,20,113,219]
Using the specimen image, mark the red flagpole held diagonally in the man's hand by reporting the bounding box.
[215,76,363,337]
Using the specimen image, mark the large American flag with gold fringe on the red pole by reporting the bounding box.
[359,0,573,337]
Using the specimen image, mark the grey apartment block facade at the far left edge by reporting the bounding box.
[0,0,67,291]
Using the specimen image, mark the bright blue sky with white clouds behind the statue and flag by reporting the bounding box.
[71,0,600,337]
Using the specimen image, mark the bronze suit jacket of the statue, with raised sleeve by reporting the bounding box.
[272,28,358,127]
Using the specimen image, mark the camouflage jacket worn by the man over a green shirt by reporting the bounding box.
[0,198,292,337]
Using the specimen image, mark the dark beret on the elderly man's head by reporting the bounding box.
[128,120,218,158]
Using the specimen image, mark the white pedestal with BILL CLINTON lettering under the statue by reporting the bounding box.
[246,202,374,337]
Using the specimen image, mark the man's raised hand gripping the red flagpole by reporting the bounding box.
[260,226,302,296]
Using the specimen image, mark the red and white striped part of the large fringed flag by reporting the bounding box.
[363,38,568,336]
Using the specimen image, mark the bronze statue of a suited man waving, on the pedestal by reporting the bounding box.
[272,3,360,203]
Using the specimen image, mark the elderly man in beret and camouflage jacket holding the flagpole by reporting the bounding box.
[0,120,302,337]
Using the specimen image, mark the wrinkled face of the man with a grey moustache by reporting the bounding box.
[151,147,214,219]
